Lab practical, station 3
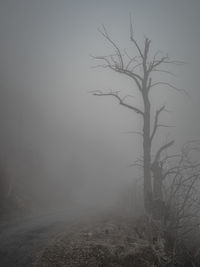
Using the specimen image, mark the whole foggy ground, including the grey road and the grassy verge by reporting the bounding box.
[0,209,197,267]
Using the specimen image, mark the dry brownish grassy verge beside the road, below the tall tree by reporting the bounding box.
[35,216,171,267]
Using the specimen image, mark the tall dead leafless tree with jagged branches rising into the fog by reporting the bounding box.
[93,17,183,214]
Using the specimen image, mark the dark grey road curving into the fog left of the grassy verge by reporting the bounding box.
[0,210,92,267]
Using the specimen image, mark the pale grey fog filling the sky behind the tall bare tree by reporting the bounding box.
[0,0,200,218]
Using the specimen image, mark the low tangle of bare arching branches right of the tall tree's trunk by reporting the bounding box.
[145,140,200,260]
